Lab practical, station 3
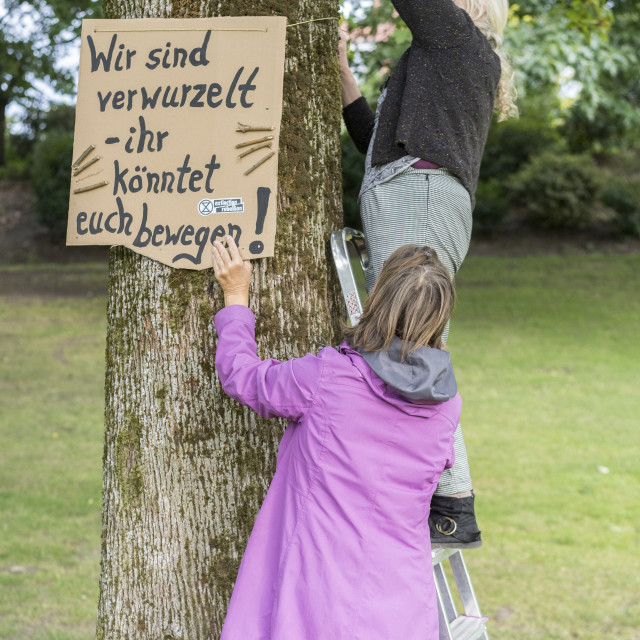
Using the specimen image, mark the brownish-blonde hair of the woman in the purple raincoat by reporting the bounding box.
[344,244,456,358]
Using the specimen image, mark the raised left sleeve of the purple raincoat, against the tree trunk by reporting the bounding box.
[214,305,324,420]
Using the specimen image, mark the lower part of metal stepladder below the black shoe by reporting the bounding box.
[431,549,489,640]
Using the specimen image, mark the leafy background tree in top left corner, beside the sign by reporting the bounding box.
[0,0,100,167]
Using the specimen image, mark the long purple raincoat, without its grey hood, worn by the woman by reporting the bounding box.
[215,305,461,640]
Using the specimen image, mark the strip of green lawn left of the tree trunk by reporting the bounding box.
[0,265,106,640]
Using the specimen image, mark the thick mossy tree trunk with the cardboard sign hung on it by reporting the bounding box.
[97,0,343,640]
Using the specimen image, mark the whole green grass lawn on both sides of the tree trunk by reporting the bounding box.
[0,255,640,640]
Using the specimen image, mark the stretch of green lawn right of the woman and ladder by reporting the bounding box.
[450,255,640,640]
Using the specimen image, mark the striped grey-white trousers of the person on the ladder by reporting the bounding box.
[360,167,472,495]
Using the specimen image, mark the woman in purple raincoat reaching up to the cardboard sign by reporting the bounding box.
[214,238,461,640]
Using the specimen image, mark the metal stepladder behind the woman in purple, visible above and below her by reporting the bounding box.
[331,227,489,640]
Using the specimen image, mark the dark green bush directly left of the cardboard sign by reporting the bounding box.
[31,130,73,240]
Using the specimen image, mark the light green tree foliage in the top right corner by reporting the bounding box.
[506,0,640,145]
